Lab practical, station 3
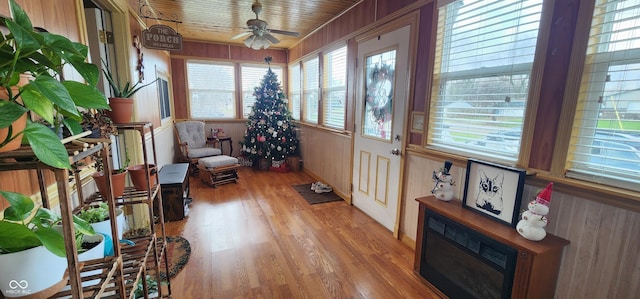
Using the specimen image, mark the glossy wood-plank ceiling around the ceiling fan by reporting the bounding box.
[139,0,361,48]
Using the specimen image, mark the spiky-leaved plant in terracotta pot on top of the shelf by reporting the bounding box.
[102,63,158,124]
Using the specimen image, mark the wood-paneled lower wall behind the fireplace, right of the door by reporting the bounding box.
[401,153,640,298]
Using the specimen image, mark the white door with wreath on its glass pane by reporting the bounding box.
[352,26,410,232]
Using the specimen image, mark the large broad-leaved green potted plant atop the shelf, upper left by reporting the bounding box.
[0,0,109,169]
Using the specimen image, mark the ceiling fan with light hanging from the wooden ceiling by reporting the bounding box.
[231,0,300,50]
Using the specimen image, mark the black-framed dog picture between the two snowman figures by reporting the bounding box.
[462,159,526,227]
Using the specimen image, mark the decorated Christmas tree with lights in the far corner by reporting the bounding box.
[240,57,298,166]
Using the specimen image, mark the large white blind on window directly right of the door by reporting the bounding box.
[428,0,542,161]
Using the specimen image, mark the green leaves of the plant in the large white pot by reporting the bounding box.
[0,191,95,257]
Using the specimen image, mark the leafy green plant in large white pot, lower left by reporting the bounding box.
[0,191,94,297]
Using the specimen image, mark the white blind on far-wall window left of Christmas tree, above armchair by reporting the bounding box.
[187,61,236,119]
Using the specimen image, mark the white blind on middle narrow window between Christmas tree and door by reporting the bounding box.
[302,57,320,124]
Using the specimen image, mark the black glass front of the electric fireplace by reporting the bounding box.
[420,210,517,298]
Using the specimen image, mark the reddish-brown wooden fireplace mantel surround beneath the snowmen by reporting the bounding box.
[413,196,569,298]
